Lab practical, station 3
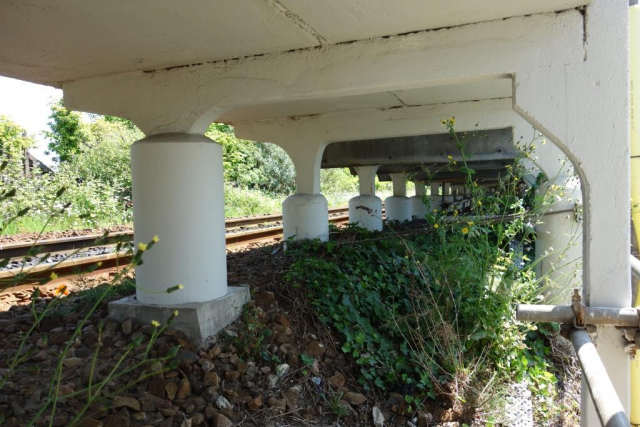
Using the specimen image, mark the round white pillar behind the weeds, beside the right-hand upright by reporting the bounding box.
[535,179,582,304]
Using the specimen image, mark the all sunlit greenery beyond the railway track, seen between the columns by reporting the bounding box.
[0,100,390,234]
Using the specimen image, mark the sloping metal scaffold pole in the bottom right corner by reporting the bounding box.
[571,329,630,427]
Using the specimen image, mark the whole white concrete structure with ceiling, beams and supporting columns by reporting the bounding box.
[0,0,631,425]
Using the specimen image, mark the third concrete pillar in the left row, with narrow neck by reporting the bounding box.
[349,166,382,231]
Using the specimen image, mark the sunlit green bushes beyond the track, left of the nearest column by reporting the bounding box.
[0,115,141,233]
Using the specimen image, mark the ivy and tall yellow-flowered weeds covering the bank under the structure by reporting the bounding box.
[288,121,576,424]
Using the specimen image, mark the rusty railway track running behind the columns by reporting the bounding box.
[0,208,349,283]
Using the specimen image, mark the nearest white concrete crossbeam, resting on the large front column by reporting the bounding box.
[62,10,585,134]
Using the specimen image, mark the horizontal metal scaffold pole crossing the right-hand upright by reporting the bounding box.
[516,304,640,328]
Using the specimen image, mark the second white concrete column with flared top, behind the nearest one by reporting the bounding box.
[278,141,329,241]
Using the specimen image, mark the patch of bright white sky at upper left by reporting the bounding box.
[0,76,62,164]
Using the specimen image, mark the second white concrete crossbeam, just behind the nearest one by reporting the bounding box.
[234,99,567,181]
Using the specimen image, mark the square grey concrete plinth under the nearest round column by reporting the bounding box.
[109,286,250,344]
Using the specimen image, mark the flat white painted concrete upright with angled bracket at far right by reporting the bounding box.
[514,0,631,427]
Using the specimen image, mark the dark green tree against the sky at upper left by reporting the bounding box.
[45,99,87,162]
